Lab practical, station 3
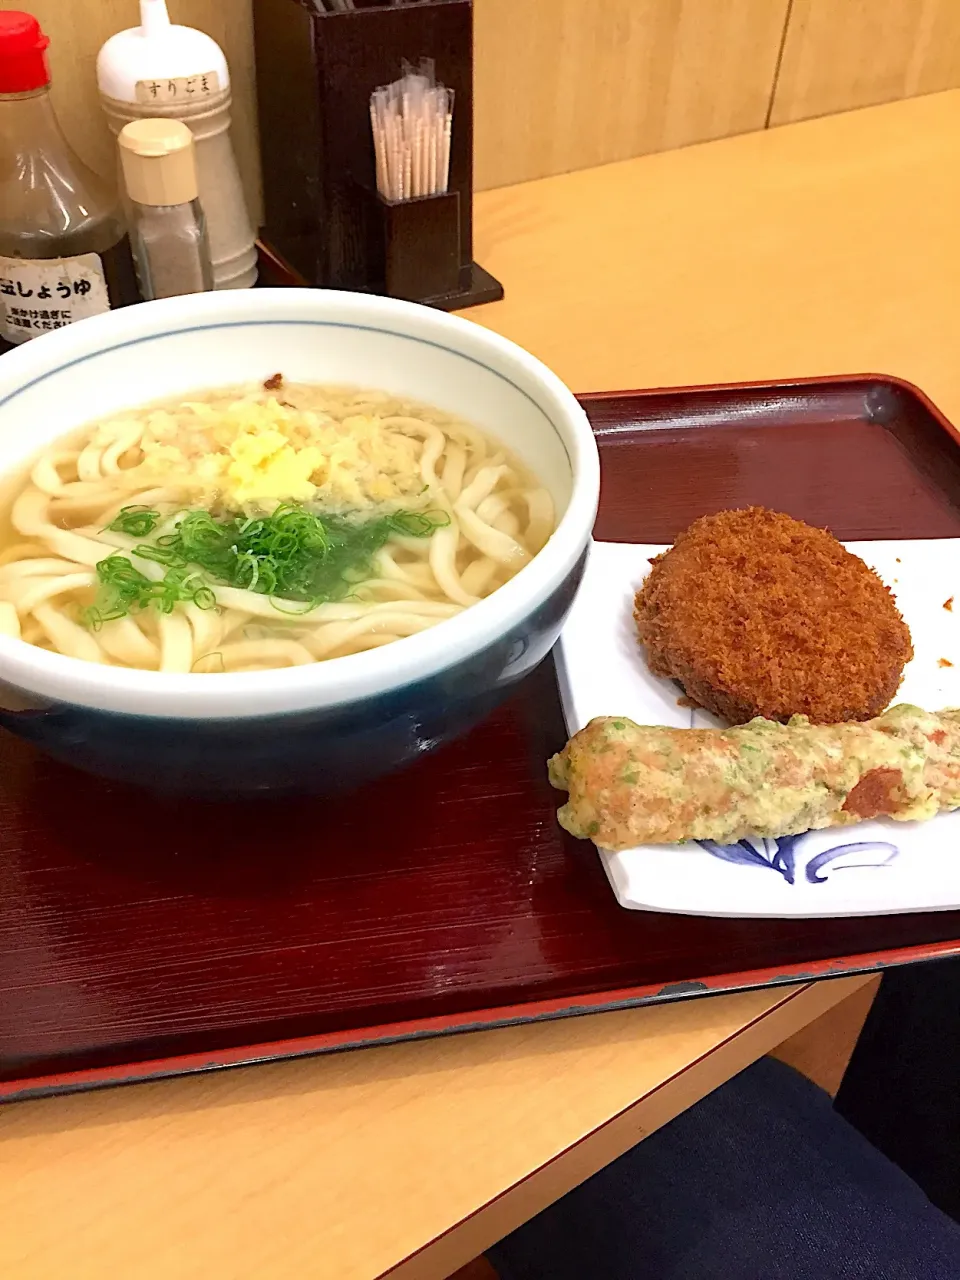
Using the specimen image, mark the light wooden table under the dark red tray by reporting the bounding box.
[7,92,960,1280]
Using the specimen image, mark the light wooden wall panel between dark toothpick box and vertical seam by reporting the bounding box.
[475,0,787,189]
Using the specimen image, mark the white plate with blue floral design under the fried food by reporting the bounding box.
[557,539,960,916]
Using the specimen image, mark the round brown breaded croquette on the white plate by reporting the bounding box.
[634,507,913,724]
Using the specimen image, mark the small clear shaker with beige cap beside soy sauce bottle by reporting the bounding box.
[116,119,214,298]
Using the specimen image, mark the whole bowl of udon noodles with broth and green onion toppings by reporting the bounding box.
[0,289,599,796]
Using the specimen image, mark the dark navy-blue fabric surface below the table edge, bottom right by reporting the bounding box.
[489,1059,960,1280]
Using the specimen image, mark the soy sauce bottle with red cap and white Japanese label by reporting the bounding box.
[0,10,140,351]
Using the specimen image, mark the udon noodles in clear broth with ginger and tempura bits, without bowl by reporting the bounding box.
[0,375,554,673]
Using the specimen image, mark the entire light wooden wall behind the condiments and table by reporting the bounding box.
[9,0,960,211]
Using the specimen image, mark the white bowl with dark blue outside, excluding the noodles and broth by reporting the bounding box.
[0,289,599,791]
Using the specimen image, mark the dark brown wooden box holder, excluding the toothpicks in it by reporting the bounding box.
[253,0,503,311]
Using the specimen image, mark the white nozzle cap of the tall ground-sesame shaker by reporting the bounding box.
[97,0,230,102]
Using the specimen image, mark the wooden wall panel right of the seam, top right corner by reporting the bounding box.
[771,0,960,124]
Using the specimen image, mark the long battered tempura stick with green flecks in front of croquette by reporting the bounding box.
[549,703,960,850]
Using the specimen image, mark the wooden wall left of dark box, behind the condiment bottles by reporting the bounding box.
[0,0,260,220]
